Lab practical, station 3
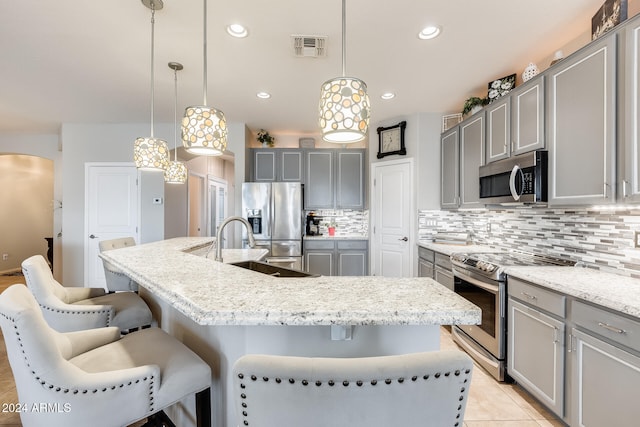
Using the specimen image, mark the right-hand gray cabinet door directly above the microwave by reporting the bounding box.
[510,75,545,156]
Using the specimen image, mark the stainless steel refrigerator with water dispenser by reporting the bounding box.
[242,182,303,270]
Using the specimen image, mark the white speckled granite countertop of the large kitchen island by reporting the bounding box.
[101,238,481,325]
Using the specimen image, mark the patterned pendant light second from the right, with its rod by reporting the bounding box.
[182,0,227,156]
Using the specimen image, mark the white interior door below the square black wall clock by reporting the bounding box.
[371,159,415,277]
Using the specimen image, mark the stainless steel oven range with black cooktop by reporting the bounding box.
[451,251,574,381]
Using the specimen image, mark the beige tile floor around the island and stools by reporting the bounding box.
[0,276,563,427]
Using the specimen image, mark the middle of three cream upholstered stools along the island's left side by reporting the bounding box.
[22,255,152,332]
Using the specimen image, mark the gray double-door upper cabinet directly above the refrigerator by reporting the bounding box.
[251,148,304,182]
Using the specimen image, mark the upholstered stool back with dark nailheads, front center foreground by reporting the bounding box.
[233,351,473,427]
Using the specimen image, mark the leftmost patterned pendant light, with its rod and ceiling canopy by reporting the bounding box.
[133,0,169,171]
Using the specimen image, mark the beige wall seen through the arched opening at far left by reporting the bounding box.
[0,154,53,273]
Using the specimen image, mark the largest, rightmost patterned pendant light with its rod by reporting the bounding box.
[319,0,370,144]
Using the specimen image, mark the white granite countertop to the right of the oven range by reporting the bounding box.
[505,266,640,318]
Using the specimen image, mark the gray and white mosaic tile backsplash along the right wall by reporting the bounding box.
[418,207,640,278]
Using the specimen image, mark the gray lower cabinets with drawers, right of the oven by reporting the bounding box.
[507,276,640,426]
